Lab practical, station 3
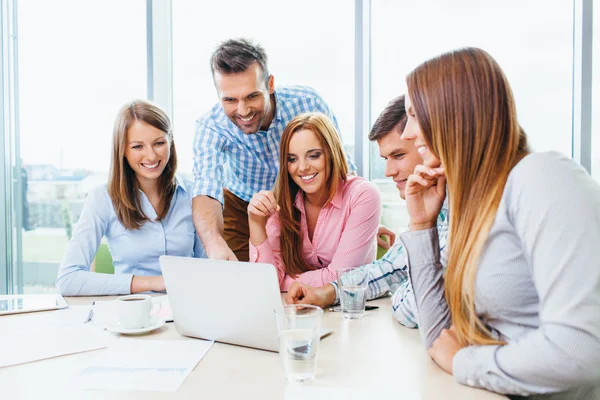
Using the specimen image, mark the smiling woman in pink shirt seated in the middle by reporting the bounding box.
[248,113,381,291]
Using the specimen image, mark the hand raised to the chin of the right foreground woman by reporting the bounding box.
[404,165,446,231]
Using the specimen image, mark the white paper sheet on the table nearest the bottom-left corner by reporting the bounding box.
[0,321,114,367]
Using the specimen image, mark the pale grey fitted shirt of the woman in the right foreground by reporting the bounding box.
[400,152,600,399]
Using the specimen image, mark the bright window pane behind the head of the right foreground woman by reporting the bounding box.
[370,0,573,229]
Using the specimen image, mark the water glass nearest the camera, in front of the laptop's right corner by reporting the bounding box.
[275,304,323,382]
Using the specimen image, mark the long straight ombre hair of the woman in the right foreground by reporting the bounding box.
[406,48,528,345]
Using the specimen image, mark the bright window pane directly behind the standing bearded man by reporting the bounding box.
[173,0,354,174]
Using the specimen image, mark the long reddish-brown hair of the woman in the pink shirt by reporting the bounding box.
[273,113,348,278]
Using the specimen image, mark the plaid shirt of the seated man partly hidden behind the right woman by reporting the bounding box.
[331,199,449,328]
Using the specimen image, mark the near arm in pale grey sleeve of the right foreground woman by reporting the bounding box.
[453,155,600,396]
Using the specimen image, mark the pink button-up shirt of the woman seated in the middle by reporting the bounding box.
[250,176,381,291]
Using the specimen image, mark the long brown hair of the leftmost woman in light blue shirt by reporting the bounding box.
[108,100,177,230]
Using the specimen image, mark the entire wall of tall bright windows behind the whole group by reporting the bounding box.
[0,0,600,293]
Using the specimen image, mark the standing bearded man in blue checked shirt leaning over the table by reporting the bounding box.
[192,39,356,261]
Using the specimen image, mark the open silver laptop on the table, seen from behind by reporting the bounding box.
[160,256,282,351]
